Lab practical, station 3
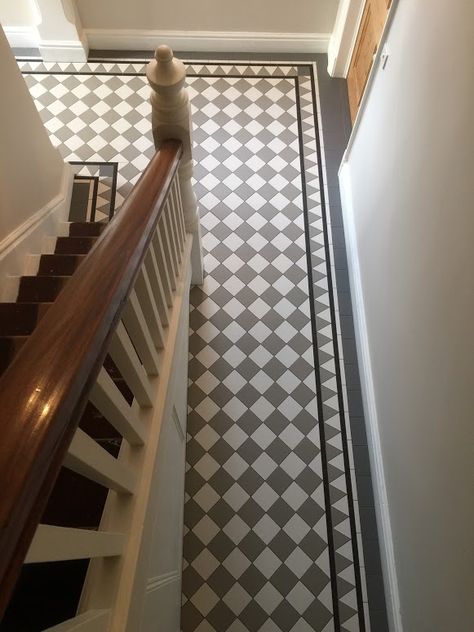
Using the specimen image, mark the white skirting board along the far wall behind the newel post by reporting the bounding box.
[84,29,330,53]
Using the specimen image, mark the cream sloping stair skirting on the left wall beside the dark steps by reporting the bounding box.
[0,164,74,301]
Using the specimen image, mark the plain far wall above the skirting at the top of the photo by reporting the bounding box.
[77,0,338,33]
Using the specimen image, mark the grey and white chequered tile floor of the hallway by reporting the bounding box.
[21,53,384,632]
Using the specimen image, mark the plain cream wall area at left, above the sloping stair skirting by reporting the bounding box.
[0,28,66,241]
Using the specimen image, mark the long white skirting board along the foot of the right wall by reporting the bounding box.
[339,163,403,632]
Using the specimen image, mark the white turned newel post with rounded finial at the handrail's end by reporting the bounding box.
[146,46,203,285]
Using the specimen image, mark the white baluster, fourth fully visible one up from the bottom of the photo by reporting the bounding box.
[109,322,153,406]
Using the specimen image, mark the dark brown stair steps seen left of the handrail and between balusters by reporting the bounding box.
[0,222,128,632]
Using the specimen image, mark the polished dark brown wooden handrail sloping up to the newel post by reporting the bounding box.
[0,140,182,618]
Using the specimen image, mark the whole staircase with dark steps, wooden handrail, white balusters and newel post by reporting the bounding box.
[0,47,203,632]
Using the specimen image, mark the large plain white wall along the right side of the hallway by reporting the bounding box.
[341,0,474,632]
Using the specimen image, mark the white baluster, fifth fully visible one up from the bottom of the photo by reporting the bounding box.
[122,290,160,375]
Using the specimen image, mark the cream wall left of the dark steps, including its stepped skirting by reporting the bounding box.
[0,22,73,292]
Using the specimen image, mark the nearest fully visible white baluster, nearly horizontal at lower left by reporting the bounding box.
[25,524,125,564]
